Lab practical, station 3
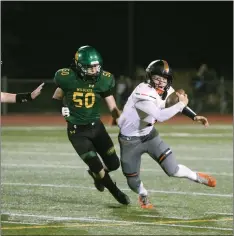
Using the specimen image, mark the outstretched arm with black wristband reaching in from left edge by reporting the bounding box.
[1,83,44,103]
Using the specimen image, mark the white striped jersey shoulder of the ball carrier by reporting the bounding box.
[133,83,158,101]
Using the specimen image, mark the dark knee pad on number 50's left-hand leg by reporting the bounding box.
[81,151,103,174]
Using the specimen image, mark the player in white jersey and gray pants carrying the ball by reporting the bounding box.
[118,60,216,209]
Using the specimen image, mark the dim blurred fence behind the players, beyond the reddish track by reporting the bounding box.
[1,72,233,115]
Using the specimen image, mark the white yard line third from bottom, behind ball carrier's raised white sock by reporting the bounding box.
[1,163,233,176]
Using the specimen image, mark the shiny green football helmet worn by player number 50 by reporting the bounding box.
[74,45,102,82]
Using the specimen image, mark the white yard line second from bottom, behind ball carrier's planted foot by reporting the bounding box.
[1,183,233,198]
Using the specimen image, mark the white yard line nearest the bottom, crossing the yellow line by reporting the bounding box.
[2,212,233,231]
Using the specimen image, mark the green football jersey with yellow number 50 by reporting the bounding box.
[54,68,115,125]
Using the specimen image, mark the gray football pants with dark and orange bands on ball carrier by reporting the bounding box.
[118,128,178,192]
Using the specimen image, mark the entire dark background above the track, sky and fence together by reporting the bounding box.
[1,1,233,115]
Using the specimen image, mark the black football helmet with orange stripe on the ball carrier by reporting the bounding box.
[146,60,173,100]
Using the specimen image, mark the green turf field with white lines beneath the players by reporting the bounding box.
[1,124,233,235]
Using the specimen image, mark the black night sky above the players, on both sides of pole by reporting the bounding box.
[1,1,233,78]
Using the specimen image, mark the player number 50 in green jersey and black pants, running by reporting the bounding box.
[53,46,130,205]
